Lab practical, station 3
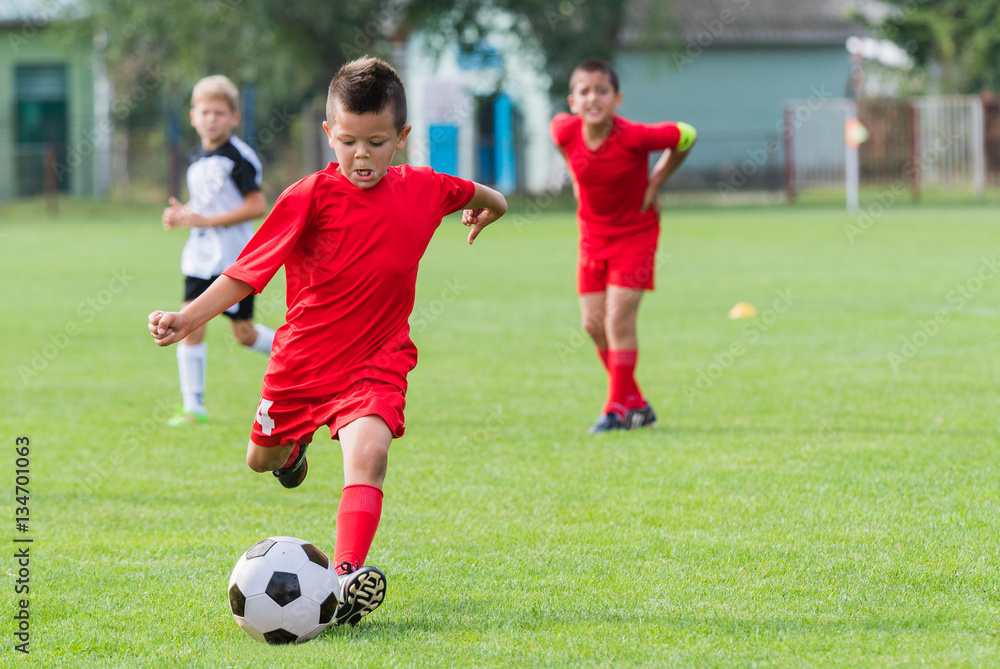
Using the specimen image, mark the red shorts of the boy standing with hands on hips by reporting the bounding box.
[576,228,660,295]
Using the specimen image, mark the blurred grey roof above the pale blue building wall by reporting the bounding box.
[621,0,888,48]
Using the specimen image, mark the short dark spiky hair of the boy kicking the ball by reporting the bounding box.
[326,56,406,132]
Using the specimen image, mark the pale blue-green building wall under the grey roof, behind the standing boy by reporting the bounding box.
[615,46,851,188]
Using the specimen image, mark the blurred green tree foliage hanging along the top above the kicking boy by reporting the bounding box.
[78,0,640,117]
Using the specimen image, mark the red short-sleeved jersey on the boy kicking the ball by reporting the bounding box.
[224,163,475,399]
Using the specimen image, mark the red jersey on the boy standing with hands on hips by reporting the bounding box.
[549,114,681,239]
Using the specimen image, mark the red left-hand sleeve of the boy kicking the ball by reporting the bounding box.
[223,177,316,293]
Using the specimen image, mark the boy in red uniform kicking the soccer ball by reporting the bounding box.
[149,57,507,625]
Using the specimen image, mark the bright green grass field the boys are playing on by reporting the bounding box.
[0,193,1000,668]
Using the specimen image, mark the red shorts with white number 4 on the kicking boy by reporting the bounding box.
[250,379,406,447]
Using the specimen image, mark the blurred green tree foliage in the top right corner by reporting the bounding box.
[879,0,1000,93]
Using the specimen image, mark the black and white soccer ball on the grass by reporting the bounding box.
[229,537,340,644]
